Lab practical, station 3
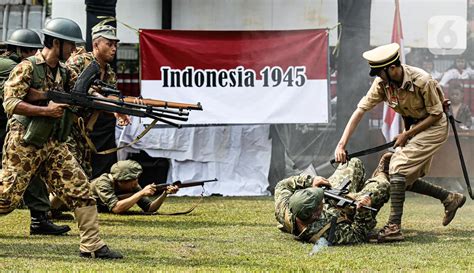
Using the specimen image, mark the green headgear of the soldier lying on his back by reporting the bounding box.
[288,188,324,221]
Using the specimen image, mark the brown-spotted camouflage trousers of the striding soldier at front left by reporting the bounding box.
[0,121,95,214]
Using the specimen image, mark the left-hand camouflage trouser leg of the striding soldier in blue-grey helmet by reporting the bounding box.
[0,123,46,214]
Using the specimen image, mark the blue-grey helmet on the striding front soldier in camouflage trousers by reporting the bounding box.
[41,18,84,43]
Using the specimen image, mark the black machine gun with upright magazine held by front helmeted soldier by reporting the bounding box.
[46,61,202,128]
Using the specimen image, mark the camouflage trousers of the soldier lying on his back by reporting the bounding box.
[328,158,390,212]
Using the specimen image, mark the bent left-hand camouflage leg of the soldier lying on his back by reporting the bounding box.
[328,158,365,192]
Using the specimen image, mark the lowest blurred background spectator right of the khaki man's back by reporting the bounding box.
[449,81,472,130]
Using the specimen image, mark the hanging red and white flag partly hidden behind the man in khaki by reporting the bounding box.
[382,0,405,142]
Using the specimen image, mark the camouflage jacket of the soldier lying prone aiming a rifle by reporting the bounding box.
[90,173,152,211]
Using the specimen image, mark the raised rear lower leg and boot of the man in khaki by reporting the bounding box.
[407,178,466,226]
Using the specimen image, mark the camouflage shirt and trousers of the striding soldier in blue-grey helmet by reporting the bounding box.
[0,51,95,214]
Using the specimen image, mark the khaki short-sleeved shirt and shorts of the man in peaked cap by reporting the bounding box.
[357,65,448,185]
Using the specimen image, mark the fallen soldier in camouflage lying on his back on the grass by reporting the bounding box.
[275,154,391,244]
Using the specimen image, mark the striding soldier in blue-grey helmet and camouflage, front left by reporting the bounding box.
[0,18,122,259]
